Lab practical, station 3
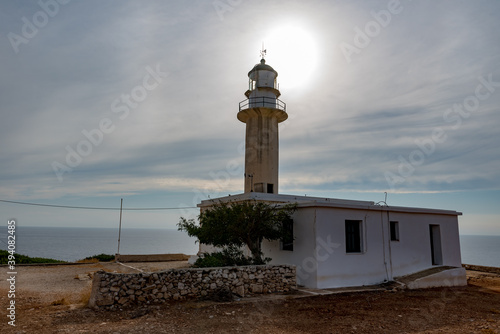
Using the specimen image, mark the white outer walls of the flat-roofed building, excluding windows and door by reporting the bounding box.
[263,207,461,288]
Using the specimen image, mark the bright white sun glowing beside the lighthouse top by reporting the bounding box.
[264,24,318,90]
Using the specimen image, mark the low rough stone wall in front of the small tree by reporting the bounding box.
[89,265,296,309]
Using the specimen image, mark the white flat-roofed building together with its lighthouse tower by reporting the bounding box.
[198,59,466,288]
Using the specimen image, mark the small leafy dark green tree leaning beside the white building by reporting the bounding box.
[177,201,297,264]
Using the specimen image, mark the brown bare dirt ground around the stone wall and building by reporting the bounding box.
[0,262,500,334]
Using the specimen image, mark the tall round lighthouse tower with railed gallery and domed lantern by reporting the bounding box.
[238,56,288,194]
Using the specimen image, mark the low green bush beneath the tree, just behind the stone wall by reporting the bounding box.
[193,246,270,268]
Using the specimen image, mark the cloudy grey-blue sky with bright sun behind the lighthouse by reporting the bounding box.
[0,0,500,235]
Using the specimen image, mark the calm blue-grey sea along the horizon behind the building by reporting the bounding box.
[0,226,500,268]
